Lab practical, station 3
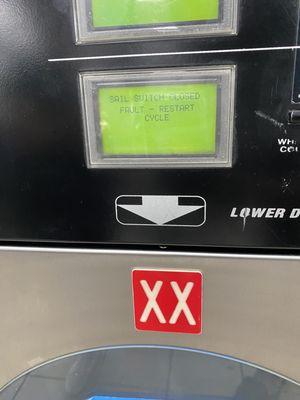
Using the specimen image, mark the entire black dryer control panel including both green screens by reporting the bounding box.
[0,0,300,249]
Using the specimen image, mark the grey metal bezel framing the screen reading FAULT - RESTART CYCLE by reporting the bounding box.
[80,65,236,168]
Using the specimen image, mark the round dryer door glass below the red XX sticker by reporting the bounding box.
[0,346,300,400]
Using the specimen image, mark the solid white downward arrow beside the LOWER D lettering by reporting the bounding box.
[117,196,205,225]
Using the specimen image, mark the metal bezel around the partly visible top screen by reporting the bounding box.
[73,0,239,44]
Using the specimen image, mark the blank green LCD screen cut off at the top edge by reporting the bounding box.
[91,0,220,28]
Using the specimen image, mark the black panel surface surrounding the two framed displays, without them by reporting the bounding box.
[0,0,300,249]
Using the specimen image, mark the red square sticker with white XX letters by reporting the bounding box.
[132,269,203,334]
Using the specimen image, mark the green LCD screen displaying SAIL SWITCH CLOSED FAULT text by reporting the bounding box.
[98,82,218,157]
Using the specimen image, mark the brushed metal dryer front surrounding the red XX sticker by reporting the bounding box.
[0,248,300,386]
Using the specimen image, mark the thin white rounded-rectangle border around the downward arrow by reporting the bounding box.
[115,194,207,228]
